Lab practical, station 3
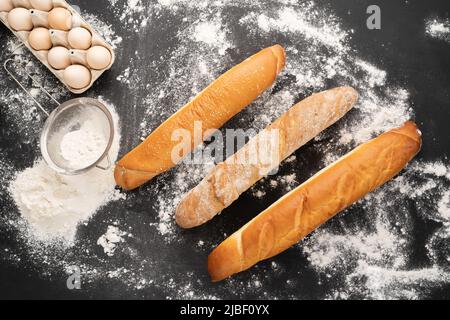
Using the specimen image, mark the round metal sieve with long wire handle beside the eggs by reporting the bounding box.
[3,45,114,175]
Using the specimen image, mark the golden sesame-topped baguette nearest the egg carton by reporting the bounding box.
[114,45,285,190]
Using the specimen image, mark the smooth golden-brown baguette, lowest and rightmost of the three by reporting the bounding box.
[208,122,422,281]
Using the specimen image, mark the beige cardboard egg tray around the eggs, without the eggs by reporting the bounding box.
[0,0,115,94]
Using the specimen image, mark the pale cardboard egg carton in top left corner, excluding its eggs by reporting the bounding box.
[0,0,115,94]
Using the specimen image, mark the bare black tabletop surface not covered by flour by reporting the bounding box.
[0,0,450,299]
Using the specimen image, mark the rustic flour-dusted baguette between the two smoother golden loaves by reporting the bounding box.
[176,87,358,228]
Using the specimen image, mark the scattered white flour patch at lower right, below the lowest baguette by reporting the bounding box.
[299,161,450,299]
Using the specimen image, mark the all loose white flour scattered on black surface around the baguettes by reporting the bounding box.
[0,0,450,299]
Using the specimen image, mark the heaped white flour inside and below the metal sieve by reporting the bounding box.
[10,102,121,243]
